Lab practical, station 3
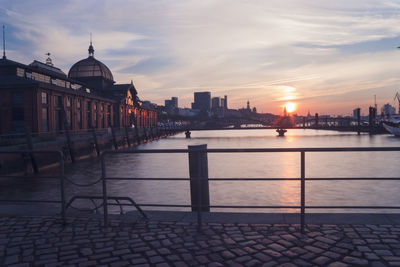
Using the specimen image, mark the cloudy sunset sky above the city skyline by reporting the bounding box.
[0,0,400,115]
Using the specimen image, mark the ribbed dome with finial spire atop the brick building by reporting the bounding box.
[68,42,114,82]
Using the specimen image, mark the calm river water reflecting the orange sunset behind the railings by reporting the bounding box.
[0,129,400,215]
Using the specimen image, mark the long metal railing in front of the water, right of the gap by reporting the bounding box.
[101,147,400,232]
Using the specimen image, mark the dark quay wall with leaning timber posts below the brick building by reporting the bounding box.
[0,126,185,173]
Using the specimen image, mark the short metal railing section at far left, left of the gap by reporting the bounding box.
[0,150,66,225]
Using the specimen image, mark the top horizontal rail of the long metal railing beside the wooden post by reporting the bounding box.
[103,147,400,155]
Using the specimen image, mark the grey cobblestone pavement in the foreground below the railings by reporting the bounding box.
[0,217,400,267]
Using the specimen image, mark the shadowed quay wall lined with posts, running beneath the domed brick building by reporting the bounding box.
[0,128,181,175]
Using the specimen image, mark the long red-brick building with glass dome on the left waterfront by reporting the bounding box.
[0,43,157,134]
